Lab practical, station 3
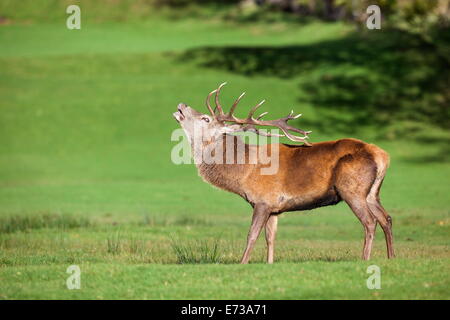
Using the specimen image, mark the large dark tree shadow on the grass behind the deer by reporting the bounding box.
[178,26,450,161]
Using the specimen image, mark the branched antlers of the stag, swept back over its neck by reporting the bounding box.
[206,82,311,146]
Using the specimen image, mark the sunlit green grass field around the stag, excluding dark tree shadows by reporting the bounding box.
[0,3,450,299]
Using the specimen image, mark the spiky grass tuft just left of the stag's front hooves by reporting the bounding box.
[172,239,222,264]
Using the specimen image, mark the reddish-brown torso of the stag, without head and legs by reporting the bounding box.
[198,139,389,213]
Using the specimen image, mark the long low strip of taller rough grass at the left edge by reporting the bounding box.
[0,214,92,233]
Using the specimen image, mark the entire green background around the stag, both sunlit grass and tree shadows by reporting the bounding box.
[0,0,450,299]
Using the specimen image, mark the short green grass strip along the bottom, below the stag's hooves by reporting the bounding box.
[1,259,448,299]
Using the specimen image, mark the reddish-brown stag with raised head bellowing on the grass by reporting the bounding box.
[173,83,395,264]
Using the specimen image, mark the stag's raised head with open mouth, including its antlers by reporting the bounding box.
[173,82,311,146]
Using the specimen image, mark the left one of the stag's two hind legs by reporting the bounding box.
[346,199,377,260]
